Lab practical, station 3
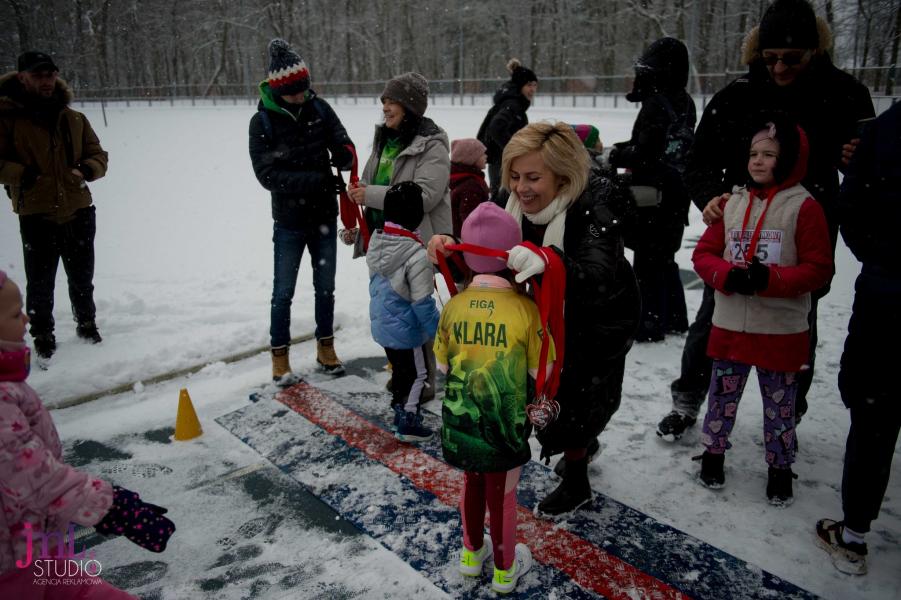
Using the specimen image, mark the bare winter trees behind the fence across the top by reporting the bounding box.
[0,0,901,95]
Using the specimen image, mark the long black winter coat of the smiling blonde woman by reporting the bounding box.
[522,170,641,456]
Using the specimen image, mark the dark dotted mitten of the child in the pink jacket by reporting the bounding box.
[94,485,175,552]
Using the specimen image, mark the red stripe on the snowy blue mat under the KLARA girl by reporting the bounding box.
[276,383,688,600]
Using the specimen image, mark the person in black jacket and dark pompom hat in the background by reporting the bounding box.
[476,58,538,208]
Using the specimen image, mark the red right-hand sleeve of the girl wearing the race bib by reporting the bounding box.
[758,198,834,298]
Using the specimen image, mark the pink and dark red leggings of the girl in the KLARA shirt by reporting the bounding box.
[460,467,522,570]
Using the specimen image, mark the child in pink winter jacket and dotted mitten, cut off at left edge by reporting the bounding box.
[0,271,175,600]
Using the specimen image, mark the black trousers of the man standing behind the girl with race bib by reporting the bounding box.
[670,285,824,417]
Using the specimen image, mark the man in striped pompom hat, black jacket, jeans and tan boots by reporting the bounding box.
[250,39,353,385]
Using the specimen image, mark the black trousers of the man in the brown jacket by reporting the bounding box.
[19,206,97,336]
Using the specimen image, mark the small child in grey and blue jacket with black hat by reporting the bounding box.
[366,181,440,442]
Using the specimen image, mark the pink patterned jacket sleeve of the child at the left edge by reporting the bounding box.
[0,383,113,526]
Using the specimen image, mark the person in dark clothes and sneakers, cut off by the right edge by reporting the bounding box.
[816,104,901,575]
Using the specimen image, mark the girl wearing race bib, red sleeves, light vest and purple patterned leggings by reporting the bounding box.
[692,115,833,506]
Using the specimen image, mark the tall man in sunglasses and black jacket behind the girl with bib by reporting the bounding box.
[657,0,873,441]
